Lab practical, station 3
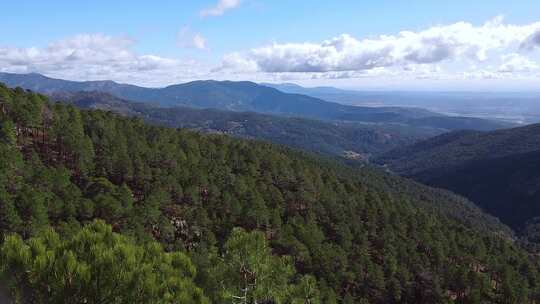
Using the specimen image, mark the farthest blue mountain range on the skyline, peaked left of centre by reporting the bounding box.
[0,73,509,130]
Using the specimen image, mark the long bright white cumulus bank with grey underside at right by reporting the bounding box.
[222,18,540,73]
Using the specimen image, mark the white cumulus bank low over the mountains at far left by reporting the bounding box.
[0,34,210,85]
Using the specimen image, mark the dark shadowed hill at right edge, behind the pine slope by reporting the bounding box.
[376,124,540,235]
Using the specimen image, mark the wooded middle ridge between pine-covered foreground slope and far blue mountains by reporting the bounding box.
[49,92,441,160]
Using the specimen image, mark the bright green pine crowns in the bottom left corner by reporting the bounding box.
[1,221,207,304]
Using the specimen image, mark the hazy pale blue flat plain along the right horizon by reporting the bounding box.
[264,83,540,124]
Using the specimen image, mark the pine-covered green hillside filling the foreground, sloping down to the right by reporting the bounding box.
[0,86,540,303]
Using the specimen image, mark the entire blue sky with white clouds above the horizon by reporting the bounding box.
[0,0,540,91]
